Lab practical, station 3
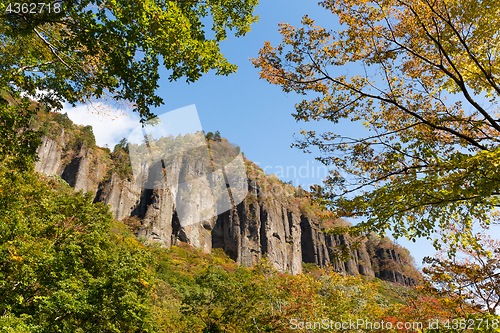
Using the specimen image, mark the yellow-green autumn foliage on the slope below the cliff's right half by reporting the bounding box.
[149,246,426,333]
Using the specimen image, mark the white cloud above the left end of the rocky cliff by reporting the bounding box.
[61,105,140,149]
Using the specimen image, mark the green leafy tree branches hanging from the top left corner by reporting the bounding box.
[0,0,257,119]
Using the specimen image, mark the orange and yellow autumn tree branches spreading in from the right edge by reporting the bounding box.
[253,0,500,247]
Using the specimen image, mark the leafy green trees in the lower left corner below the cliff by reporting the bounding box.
[0,164,154,332]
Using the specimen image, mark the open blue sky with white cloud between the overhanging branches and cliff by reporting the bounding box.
[65,0,435,264]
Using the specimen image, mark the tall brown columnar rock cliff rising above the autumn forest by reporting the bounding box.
[36,135,417,285]
